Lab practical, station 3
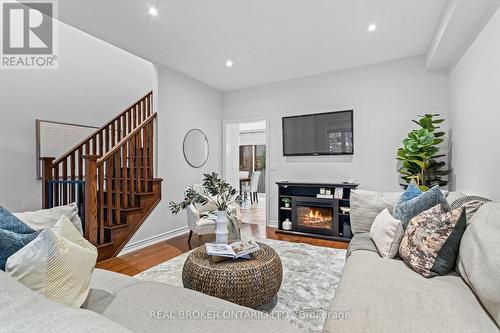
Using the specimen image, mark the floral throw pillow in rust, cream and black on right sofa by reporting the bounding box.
[399,204,466,277]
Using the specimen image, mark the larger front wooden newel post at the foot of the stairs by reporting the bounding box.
[82,155,99,245]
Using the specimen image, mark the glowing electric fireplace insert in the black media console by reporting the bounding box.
[292,198,335,235]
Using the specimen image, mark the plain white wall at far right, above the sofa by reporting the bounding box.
[450,11,500,200]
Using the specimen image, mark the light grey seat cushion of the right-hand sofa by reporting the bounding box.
[324,251,498,333]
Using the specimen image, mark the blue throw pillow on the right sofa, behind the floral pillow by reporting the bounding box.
[393,185,451,230]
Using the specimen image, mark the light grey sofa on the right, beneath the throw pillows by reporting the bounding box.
[324,194,500,333]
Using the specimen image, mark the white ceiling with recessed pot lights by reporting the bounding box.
[58,0,445,91]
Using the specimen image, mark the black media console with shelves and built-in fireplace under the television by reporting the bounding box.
[276,182,359,242]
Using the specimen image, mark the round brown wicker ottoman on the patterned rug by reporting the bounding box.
[182,243,283,308]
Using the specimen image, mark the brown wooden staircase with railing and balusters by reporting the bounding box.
[41,92,162,261]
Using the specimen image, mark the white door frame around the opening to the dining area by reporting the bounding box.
[222,116,271,227]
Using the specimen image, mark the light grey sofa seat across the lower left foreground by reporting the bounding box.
[0,269,301,333]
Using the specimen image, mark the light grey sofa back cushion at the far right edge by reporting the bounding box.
[457,202,500,326]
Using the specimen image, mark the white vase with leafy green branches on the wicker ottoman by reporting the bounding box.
[169,172,241,244]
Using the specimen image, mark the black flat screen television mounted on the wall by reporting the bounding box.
[283,110,354,156]
